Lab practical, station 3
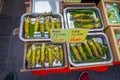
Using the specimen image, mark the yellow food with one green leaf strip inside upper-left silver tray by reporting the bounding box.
[22,12,62,39]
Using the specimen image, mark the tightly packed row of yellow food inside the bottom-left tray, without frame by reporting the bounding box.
[26,43,65,69]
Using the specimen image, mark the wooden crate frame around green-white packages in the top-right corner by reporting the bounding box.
[97,0,120,28]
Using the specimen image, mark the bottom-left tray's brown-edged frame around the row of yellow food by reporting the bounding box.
[23,42,67,71]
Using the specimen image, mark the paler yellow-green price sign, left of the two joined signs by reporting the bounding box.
[50,29,69,42]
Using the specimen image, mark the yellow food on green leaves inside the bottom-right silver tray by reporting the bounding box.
[70,38,107,63]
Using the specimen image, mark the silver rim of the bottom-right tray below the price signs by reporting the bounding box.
[67,33,113,67]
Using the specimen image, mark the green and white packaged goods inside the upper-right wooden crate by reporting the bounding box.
[105,3,120,24]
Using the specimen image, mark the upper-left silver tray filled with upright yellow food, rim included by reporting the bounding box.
[19,13,64,41]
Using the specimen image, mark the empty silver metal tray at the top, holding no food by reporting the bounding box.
[30,0,61,13]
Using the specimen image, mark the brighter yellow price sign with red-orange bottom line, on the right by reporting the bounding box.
[69,28,89,42]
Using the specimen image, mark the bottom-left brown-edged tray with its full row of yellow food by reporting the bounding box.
[22,41,68,71]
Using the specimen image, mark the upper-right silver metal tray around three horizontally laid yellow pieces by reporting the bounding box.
[64,6,104,32]
